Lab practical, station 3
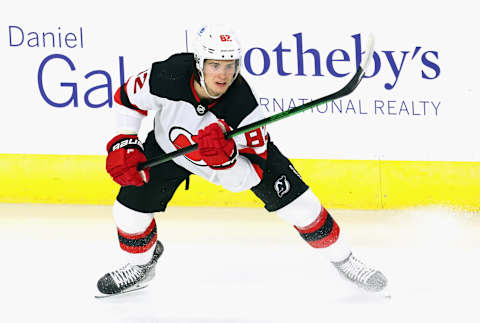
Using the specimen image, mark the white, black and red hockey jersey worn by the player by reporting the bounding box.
[115,53,268,192]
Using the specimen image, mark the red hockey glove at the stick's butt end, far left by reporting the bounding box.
[106,135,150,186]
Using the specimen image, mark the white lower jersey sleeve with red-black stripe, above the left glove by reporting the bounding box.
[114,69,162,133]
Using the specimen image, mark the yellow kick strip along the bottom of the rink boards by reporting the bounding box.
[0,154,480,210]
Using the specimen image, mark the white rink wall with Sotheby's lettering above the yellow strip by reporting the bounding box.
[0,0,480,161]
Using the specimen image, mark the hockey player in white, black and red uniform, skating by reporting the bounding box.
[97,26,387,294]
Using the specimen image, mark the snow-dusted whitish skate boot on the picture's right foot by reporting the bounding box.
[332,253,387,292]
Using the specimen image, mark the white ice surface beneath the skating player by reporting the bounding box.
[0,204,480,323]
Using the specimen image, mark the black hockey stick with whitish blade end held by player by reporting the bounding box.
[137,34,374,170]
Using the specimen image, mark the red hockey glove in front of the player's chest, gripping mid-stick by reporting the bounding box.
[192,120,238,169]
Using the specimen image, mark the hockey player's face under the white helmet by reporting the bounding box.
[203,59,236,96]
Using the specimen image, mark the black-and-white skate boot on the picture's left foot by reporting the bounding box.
[97,241,163,297]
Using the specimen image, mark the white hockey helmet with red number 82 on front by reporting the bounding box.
[193,25,242,99]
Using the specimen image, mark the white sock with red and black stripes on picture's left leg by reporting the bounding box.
[112,201,157,265]
